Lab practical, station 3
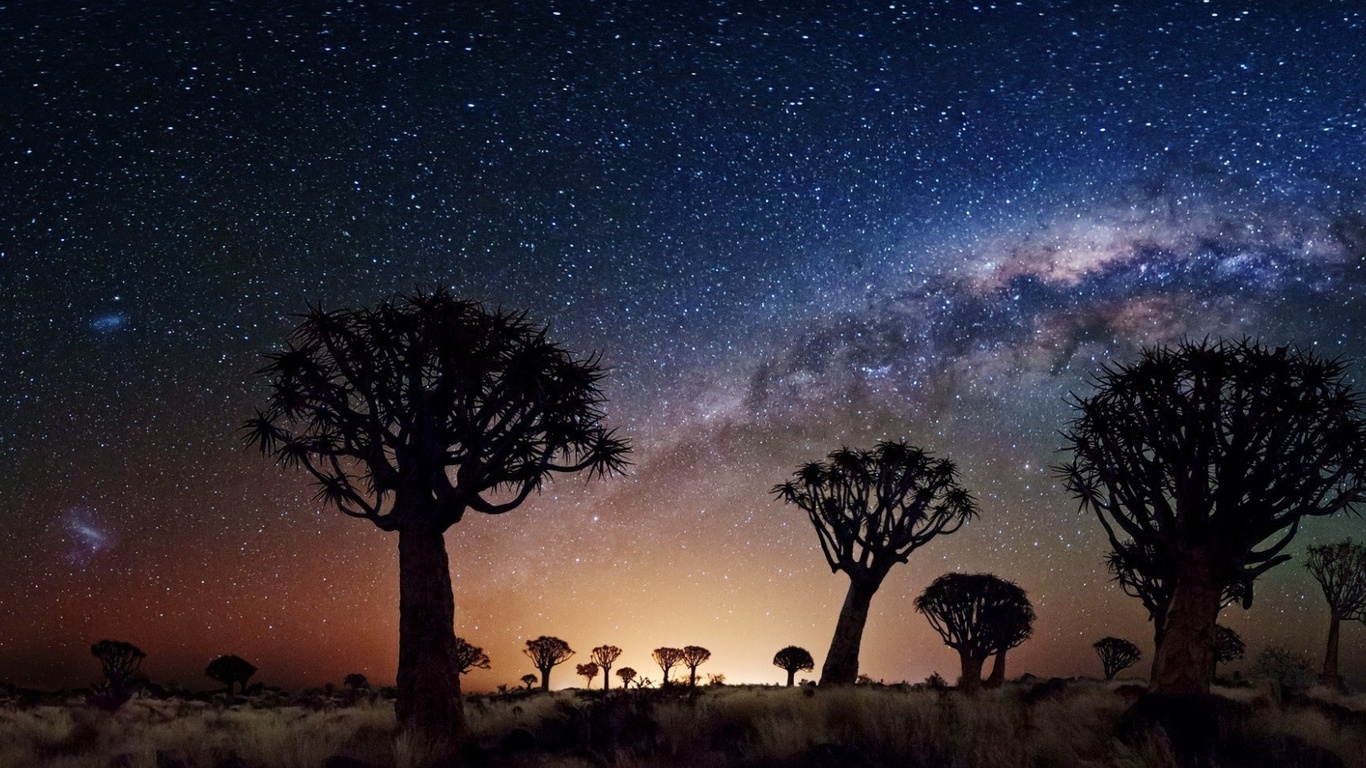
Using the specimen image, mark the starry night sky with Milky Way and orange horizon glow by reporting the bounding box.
[0,0,1366,690]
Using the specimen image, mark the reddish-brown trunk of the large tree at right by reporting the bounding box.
[1149,549,1221,696]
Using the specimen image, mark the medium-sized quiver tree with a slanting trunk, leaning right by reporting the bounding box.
[772,440,977,685]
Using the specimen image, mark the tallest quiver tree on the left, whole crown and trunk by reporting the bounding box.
[245,288,628,748]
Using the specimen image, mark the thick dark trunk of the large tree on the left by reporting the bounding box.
[393,530,467,750]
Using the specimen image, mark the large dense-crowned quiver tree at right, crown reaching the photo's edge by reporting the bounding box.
[1059,340,1366,694]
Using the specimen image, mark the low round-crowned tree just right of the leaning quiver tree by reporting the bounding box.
[915,574,1033,693]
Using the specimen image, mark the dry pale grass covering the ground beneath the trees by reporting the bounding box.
[0,682,1366,768]
